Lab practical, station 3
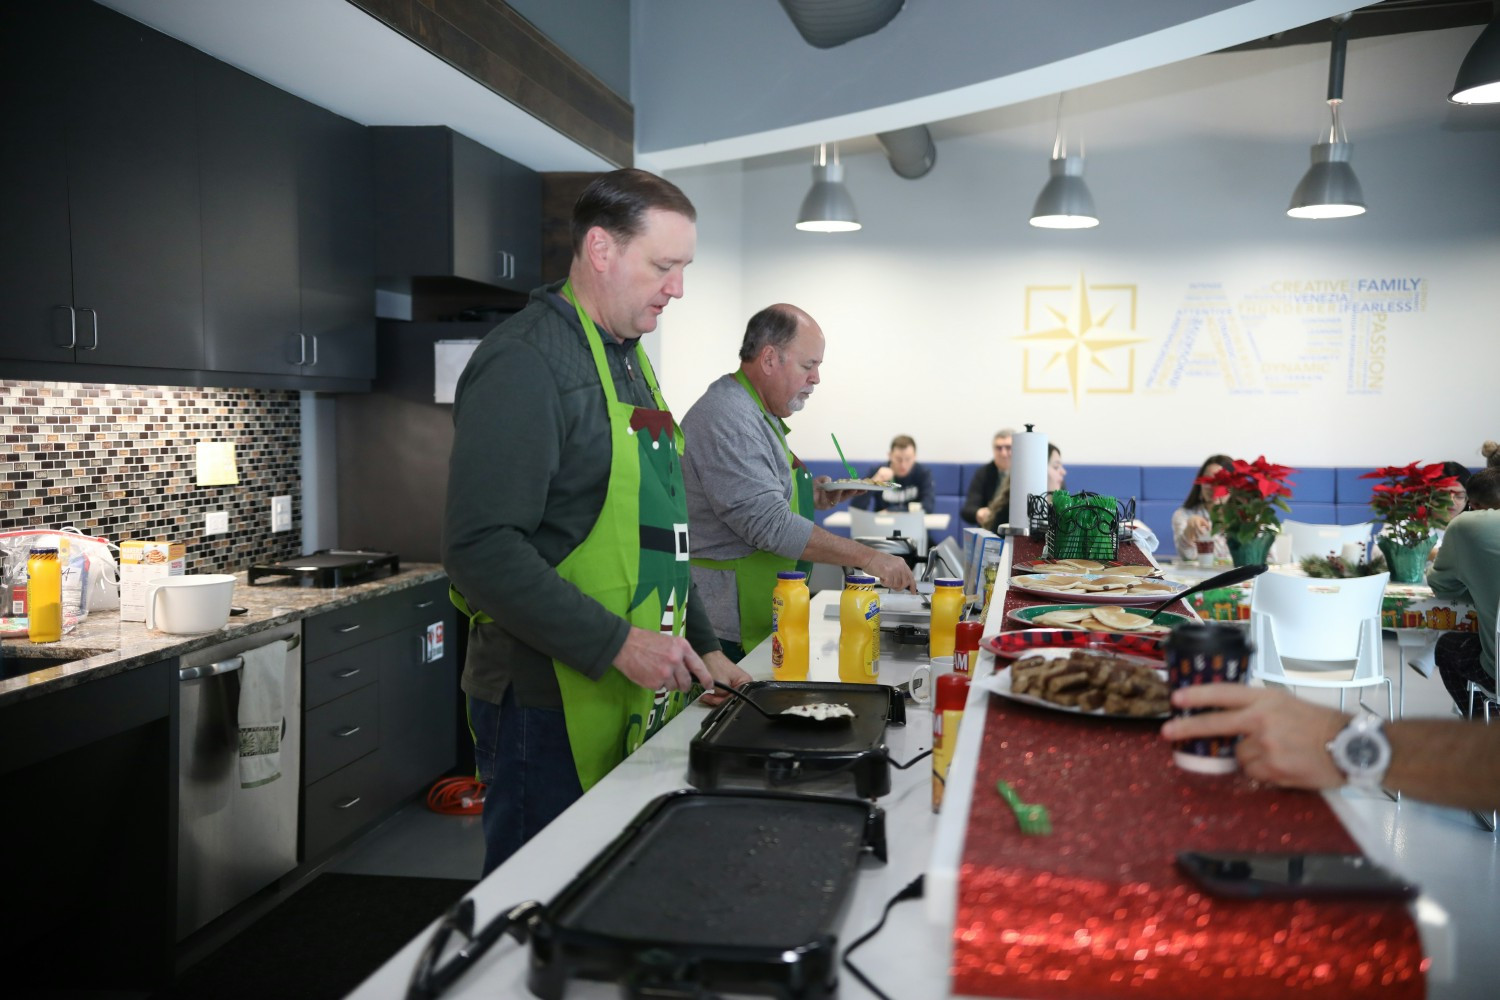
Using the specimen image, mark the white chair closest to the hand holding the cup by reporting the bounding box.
[1250,573,1395,720]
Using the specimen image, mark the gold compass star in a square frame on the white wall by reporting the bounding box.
[1013,271,1146,409]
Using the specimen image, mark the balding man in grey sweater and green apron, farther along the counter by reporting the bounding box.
[683,304,915,661]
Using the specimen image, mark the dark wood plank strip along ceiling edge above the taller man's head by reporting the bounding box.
[350,0,636,166]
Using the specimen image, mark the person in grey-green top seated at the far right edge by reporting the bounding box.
[1427,466,1500,712]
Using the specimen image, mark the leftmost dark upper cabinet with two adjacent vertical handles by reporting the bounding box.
[0,0,207,367]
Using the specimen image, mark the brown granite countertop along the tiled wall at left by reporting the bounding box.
[0,562,444,706]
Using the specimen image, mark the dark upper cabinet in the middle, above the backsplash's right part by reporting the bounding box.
[198,60,375,379]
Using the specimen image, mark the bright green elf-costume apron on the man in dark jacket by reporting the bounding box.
[450,283,692,792]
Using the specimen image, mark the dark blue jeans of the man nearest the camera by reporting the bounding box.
[468,691,584,876]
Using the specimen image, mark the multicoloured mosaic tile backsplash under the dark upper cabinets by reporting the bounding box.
[0,379,302,573]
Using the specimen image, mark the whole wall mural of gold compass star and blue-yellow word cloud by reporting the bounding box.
[1013,273,1428,409]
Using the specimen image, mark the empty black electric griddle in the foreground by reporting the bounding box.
[527,789,885,1000]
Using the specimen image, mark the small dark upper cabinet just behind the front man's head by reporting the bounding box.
[372,126,542,292]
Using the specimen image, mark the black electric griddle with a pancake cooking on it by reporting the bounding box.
[687,681,906,799]
